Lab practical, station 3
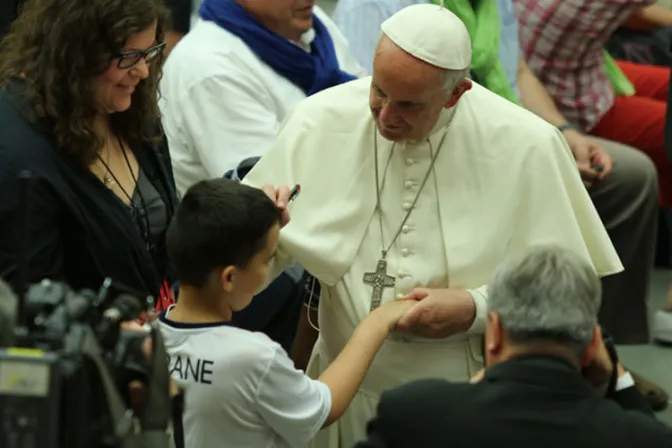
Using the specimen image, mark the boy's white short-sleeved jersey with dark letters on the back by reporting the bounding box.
[159,309,331,448]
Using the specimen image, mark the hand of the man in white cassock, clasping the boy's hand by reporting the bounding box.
[397,288,476,339]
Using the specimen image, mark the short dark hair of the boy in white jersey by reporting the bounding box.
[166,179,282,288]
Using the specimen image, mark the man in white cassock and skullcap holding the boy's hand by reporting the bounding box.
[245,4,622,448]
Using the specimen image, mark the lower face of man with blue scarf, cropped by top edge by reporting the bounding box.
[240,0,315,40]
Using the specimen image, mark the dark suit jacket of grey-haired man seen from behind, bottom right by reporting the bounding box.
[356,357,672,448]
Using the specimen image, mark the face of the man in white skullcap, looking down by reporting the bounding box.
[369,37,454,141]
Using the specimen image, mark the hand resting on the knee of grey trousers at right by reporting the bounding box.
[563,129,613,188]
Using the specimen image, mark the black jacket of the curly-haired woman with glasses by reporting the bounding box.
[0,82,177,296]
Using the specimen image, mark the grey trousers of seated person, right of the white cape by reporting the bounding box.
[589,140,658,344]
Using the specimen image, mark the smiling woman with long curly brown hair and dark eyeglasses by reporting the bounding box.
[0,0,177,305]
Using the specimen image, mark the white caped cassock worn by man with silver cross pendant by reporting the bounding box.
[240,78,622,448]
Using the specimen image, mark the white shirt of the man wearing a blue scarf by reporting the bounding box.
[159,6,365,194]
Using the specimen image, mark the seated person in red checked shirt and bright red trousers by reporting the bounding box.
[514,0,672,354]
